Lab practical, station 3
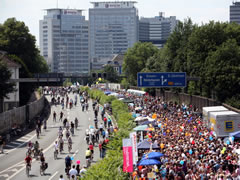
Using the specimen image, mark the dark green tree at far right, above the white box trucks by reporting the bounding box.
[205,39,240,102]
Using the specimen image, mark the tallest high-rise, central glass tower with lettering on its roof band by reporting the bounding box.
[89,1,138,68]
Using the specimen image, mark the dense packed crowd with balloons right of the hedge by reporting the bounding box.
[123,95,240,180]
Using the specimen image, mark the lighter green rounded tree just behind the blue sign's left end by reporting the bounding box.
[123,42,158,85]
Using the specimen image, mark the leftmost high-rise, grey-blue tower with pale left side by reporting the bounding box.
[39,9,90,74]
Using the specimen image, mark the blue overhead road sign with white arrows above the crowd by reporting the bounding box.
[137,72,186,88]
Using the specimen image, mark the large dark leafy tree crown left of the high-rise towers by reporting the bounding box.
[0,18,48,73]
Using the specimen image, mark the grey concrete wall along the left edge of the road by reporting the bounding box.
[0,96,45,134]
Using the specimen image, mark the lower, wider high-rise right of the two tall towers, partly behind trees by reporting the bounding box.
[139,12,178,48]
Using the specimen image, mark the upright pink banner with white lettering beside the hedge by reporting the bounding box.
[123,139,133,172]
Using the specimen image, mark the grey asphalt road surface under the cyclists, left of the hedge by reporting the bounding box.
[0,94,100,180]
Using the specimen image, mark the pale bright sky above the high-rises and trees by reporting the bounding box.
[0,0,235,45]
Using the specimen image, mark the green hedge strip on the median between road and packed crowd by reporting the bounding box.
[81,88,136,180]
